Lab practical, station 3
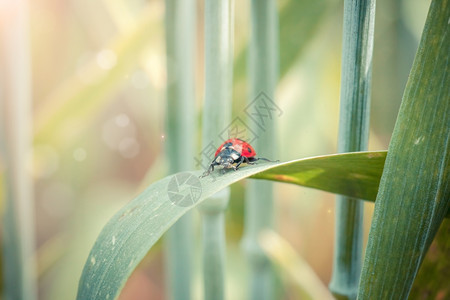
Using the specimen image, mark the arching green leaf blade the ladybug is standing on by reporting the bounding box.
[77,151,386,299]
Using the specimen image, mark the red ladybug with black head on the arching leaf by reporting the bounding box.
[200,138,273,177]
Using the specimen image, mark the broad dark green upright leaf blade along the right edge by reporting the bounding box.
[358,0,450,299]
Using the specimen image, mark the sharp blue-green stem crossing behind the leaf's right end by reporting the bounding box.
[330,0,375,299]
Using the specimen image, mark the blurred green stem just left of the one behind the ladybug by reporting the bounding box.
[165,0,196,300]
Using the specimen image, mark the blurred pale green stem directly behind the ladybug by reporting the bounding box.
[200,0,234,299]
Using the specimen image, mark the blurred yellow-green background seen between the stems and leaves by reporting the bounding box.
[0,0,429,300]
